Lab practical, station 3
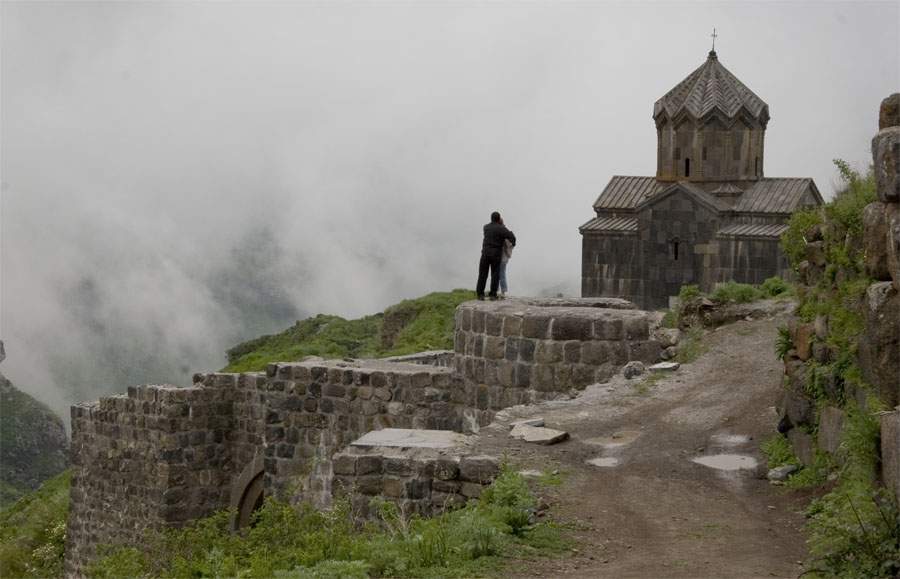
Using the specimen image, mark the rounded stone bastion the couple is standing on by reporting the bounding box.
[454,298,662,411]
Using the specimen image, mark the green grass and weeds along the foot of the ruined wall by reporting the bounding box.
[85,465,575,578]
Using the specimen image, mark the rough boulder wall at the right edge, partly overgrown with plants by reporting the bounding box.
[779,93,900,500]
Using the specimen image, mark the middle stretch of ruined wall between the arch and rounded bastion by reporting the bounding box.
[246,360,472,506]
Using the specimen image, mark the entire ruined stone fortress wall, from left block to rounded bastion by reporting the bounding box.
[66,298,671,574]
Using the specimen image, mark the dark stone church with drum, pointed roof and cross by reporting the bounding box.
[579,50,822,309]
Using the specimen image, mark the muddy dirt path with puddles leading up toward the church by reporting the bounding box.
[478,305,810,578]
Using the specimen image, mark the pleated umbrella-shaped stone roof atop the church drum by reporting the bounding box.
[653,50,769,127]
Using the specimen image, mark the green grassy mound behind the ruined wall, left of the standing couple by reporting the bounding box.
[223,289,475,372]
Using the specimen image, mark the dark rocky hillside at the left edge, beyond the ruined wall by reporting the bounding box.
[0,341,69,506]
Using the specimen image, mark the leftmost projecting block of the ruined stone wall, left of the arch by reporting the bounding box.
[66,386,233,571]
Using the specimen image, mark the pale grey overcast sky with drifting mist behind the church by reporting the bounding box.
[0,0,900,415]
